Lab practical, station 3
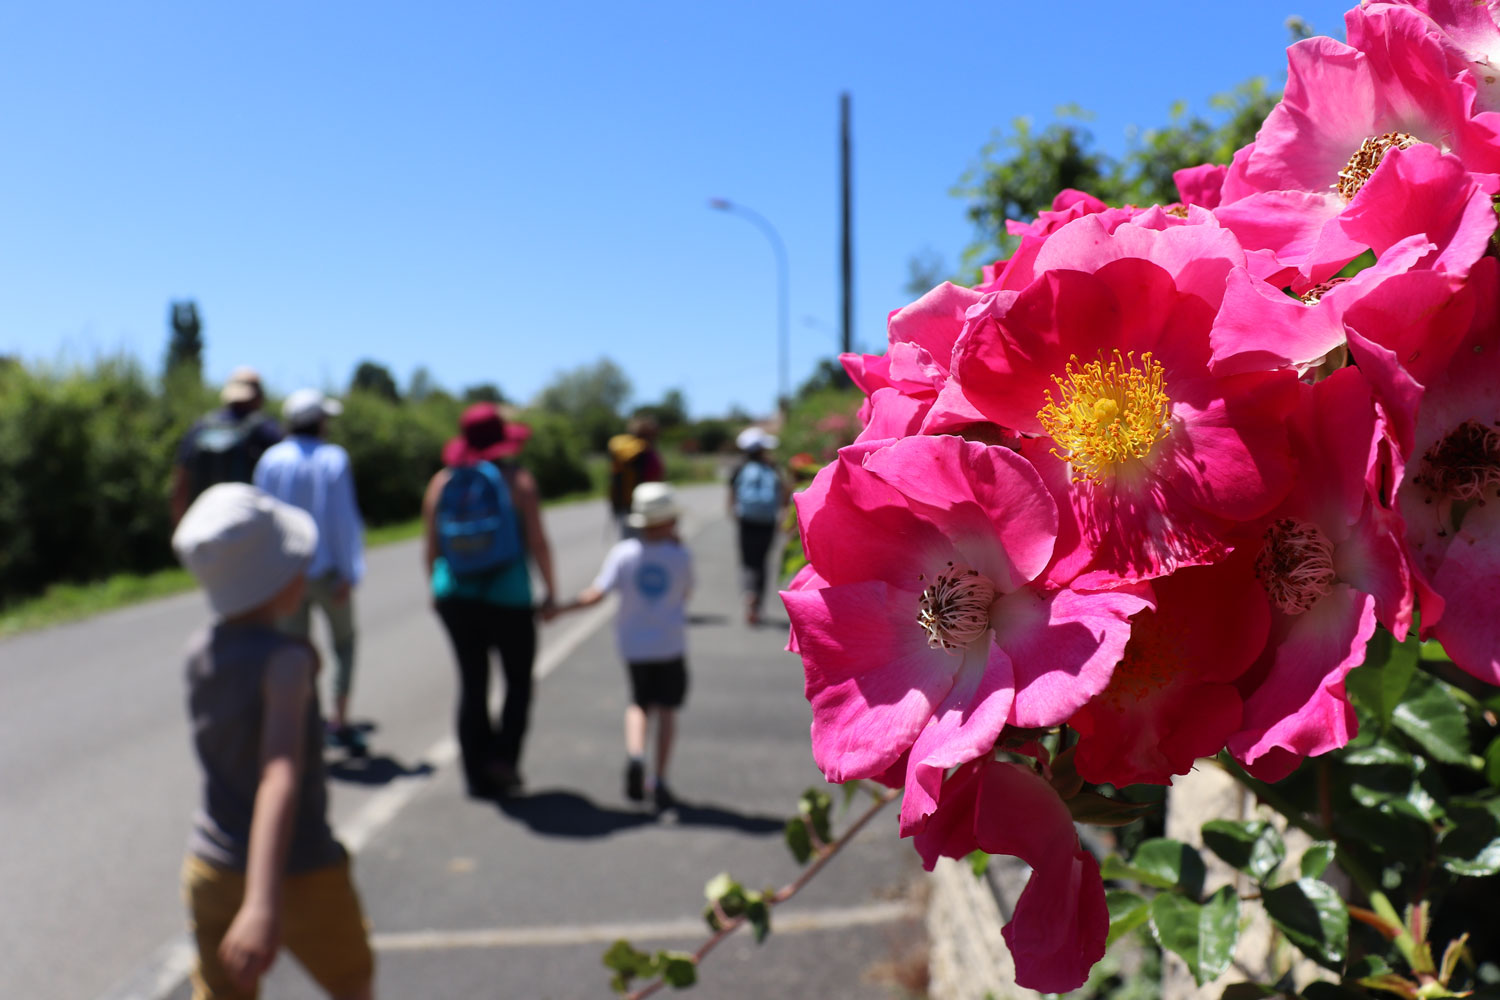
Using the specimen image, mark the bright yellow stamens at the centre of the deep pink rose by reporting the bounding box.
[1037,351,1172,483]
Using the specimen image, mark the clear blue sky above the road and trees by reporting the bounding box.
[0,0,1353,414]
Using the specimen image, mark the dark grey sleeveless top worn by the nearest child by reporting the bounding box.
[188,625,345,873]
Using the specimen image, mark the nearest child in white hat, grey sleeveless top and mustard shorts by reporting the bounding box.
[173,483,375,1000]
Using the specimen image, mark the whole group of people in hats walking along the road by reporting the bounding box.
[171,369,788,1000]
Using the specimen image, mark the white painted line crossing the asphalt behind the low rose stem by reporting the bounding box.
[372,903,921,952]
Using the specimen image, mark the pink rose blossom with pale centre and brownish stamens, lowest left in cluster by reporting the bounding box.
[782,436,1149,828]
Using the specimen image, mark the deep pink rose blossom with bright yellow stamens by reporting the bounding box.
[948,216,1296,586]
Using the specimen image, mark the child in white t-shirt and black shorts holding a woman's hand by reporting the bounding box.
[558,483,693,810]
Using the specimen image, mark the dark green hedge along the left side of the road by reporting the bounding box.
[0,358,590,606]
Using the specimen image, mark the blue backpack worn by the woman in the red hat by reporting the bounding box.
[437,462,521,576]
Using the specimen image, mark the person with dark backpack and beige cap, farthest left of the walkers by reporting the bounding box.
[170,367,282,526]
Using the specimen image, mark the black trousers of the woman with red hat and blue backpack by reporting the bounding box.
[438,597,537,789]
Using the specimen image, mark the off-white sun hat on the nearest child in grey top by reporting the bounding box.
[173,483,318,618]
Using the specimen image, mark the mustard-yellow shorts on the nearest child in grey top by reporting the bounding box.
[183,855,375,1000]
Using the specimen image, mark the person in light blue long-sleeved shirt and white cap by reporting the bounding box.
[255,388,368,757]
